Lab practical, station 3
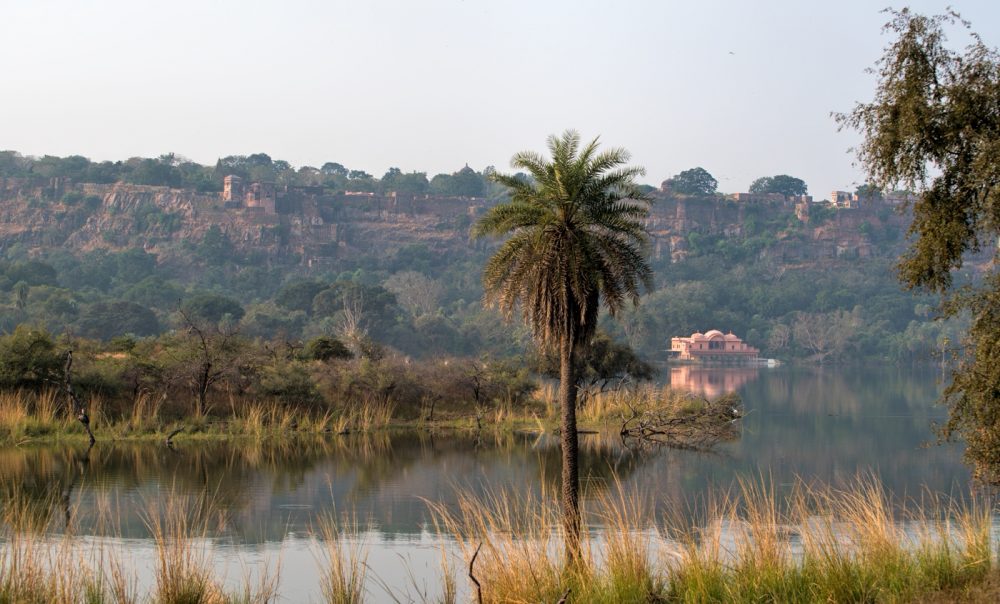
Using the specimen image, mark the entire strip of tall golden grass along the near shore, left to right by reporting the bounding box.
[0,479,997,604]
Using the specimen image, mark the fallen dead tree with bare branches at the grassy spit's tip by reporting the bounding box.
[621,394,743,451]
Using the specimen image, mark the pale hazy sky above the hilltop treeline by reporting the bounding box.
[0,0,1000,197]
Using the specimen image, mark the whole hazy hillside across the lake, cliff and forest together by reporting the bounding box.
[0,152,976,362]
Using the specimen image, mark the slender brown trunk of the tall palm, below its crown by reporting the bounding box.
[559,338,580,563]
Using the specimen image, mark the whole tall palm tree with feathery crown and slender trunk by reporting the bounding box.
[473,130,652,559]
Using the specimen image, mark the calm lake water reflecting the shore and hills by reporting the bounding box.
[0,367,970,601]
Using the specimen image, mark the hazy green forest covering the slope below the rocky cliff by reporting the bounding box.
[0,201,952,363]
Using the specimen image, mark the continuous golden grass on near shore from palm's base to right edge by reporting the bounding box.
[430,479,993,603]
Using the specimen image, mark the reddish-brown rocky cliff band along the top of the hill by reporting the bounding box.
[0,181,909,266]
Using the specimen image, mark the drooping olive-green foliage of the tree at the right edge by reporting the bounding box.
[838,9,1000,481]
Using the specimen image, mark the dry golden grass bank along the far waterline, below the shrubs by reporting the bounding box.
[0,385,724,446]
